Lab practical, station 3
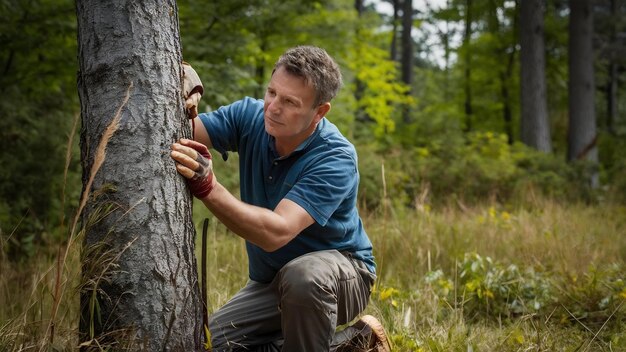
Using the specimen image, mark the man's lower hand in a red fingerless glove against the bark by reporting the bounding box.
[170,138,216,199]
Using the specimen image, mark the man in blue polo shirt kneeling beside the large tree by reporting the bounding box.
[171,46,390,352]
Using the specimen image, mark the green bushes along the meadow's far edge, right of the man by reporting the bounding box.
[359,132,590,206]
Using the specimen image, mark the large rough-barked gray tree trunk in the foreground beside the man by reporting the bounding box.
[76,0,203,351]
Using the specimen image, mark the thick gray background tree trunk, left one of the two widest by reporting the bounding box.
[520,0,552,153]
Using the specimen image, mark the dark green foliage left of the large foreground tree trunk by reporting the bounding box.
[0,1,78,259]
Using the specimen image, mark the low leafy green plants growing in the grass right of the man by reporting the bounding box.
[416,253,626,329]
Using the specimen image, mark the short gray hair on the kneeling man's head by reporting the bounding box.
[272,45,342,106]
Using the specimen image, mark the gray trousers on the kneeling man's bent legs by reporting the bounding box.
[209,250,376,352]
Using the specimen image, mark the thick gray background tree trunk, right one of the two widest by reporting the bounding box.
[567,0,598,187]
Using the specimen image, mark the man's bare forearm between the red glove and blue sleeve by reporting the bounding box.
[202,182,295,252]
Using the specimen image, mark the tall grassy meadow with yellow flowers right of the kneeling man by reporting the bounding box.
[366,199,626,351]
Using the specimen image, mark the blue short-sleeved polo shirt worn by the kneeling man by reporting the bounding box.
[200,98,376,283]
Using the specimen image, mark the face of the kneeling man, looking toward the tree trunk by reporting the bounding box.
[263,67,330,143]
